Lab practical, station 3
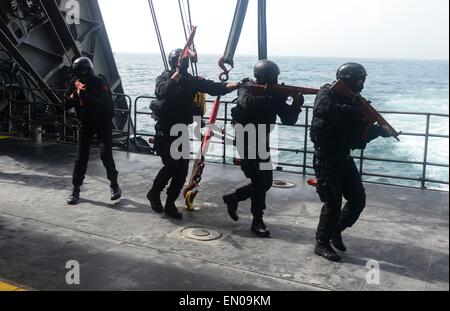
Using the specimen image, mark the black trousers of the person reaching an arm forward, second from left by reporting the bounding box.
[150,136,189,203]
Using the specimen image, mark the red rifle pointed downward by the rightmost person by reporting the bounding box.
[331,80,401,141]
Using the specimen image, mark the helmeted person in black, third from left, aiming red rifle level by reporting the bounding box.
[223,60,304,238]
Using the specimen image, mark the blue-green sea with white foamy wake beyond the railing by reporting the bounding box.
[115,53,449,190]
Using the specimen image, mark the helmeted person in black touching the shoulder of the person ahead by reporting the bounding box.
[147,49,237,219]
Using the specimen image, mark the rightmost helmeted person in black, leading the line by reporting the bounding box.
[310,63,389,262]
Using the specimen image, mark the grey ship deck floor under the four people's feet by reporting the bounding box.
[0,139,449,291]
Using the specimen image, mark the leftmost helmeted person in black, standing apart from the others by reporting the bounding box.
[64,57,122,205]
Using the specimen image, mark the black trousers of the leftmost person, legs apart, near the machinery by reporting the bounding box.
[73,123,119,187]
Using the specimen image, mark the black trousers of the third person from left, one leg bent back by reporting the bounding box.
[235,160,273,219]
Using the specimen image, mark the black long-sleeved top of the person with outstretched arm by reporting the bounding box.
[155,71,229,134]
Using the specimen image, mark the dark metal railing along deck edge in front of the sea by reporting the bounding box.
[133,96,449,189]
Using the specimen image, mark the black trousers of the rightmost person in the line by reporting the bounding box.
[314,152,366,241]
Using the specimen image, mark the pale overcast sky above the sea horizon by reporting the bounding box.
[99,0,449,59]
